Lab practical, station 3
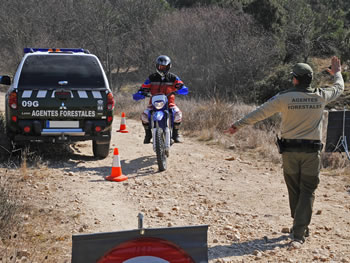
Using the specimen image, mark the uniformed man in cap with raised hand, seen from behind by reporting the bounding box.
[224,57,344,244]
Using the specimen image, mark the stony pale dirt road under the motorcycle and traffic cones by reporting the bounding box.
[0,96,350,262]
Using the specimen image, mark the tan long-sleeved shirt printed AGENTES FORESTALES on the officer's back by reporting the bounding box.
[234,72,344,140]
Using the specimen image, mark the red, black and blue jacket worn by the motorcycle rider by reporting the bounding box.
[141,72,183,107]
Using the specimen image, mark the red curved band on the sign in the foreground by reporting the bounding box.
[98,237,195,263]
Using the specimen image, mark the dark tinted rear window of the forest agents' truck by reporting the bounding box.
[18,54,105,89]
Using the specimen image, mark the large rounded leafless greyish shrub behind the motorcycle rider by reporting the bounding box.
[149,6,277,100]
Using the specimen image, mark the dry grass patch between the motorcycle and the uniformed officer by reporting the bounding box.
[178,100,280,163]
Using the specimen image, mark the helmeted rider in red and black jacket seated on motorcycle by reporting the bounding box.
[139,55,184,144]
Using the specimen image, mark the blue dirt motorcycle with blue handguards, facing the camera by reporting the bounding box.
[133,86,188,172]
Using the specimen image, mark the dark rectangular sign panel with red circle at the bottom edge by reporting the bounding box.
[72,225,208,263]
